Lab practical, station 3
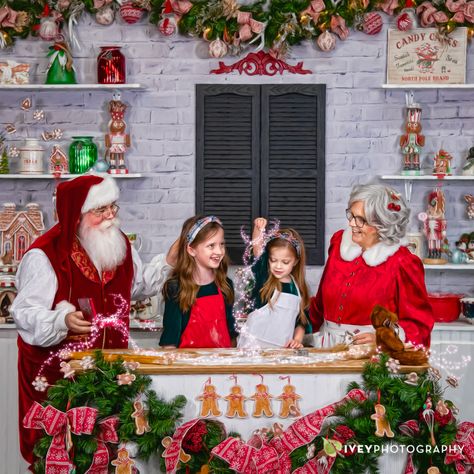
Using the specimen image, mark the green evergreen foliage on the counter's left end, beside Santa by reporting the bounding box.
[35,351,186,474]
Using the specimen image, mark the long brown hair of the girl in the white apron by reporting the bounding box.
[260,229,309,324]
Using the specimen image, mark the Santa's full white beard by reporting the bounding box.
[78,218,127,273]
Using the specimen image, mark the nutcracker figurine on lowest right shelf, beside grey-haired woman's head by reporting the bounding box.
[418,188,447,265]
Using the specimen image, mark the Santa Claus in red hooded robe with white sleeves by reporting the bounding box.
[11,175,174,463]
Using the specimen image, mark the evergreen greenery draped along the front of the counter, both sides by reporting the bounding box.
[31,351,468,474]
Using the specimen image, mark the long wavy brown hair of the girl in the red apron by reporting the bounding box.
[163,216,234,312]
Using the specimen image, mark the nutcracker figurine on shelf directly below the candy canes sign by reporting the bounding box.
[400,103,425,175]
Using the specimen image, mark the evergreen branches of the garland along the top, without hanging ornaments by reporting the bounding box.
[0,0,474,54]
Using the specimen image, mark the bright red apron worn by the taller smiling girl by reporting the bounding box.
[179,288,231,348]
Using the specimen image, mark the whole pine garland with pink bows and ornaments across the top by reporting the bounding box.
[0,0,474,57]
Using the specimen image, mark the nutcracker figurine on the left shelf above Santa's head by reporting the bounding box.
[105,94,130,174]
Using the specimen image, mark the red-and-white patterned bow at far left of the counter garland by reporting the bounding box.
[23,402,97,474]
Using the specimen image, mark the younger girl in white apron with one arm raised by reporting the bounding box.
[238,217,311,349]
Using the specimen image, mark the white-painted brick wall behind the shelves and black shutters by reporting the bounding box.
[0,18,474,293]
